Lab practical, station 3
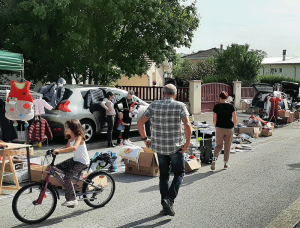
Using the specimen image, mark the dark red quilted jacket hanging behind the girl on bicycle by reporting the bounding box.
[28,117,53,143]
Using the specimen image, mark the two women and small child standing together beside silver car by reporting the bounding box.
[101,90,134,147]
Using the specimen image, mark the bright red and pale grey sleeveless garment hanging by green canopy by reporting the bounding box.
[5,80,34,121]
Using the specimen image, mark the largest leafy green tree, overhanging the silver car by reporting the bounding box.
[0,0,199,84]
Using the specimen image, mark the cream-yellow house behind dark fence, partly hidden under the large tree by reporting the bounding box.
[115,59,173,86]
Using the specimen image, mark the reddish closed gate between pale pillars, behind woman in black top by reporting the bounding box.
[201,83,232,112]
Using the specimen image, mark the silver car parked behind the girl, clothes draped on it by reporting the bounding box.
[42,85,149,142]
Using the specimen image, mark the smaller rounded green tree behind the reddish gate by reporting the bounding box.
[215,44,267,80]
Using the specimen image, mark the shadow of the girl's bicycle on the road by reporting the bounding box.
[13,208,95,228]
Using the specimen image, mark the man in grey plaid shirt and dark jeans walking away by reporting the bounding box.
[138,84,192,216]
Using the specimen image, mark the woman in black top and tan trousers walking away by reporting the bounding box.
[211,91,237,170]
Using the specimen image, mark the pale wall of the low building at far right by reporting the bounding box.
[259,64,300,80]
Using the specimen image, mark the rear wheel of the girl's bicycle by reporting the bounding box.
[82,172,115,208]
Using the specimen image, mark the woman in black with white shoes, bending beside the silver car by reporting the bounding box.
[115,90,134,145]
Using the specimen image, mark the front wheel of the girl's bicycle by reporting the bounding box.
[12,183,57,224]
